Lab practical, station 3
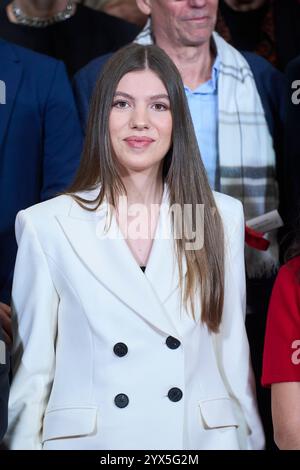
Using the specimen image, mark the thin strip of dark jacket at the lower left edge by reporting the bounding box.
[0,327,9,442]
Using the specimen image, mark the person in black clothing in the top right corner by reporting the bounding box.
[216,0,300,70]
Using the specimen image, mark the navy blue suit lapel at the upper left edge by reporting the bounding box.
[0,41,22,148]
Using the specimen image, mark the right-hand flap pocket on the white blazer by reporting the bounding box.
[199,397,239,429]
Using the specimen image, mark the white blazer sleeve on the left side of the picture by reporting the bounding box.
[6,211,59,450]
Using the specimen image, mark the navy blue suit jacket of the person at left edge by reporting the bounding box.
[0,39,82,303]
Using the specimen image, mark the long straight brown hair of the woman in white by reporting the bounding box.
[68,44,224,332]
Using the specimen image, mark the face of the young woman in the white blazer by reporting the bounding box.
[109,69,172,172]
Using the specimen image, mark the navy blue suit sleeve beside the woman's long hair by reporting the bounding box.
[40,62,83,201]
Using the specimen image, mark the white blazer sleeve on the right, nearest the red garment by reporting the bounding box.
[216,201,264,450]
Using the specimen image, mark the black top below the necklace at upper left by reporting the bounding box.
[0,4,140,77]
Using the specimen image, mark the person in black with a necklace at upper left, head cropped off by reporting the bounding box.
[0,0,139,76]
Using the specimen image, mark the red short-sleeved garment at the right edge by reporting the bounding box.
[262,256,300,386]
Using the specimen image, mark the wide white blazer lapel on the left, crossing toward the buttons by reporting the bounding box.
[57,196,179,337]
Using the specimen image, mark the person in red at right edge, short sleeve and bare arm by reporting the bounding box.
[262,242,300,450]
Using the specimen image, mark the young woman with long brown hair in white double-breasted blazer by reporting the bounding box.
[4,45,264,449]
